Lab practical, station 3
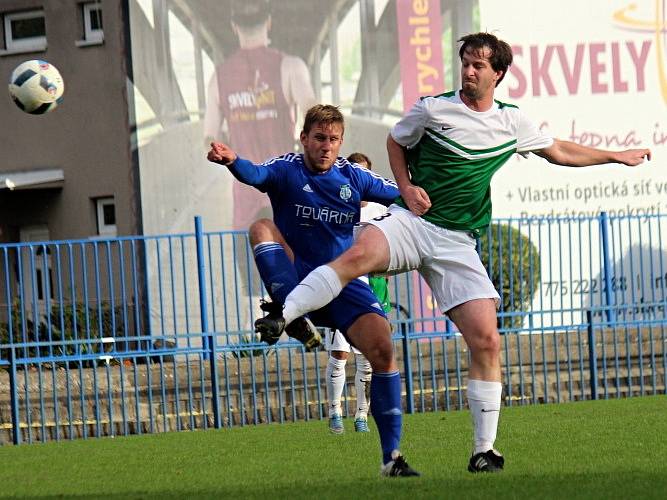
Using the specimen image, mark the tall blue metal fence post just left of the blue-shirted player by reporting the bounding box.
[195,215,222,429]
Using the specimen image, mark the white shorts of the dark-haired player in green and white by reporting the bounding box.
[368,205,500,313]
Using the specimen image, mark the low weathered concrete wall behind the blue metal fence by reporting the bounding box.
[0,326,665,445]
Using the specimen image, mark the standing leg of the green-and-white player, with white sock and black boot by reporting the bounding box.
[447,299,505,472]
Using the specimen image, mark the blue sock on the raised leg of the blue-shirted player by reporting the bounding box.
[253,241,299,304]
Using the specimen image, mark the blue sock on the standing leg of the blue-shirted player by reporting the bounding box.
[371,371,403,464]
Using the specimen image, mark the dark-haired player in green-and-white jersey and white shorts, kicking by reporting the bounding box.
[258,33,651,472]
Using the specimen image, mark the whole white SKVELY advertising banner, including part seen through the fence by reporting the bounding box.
[479,0,667,324]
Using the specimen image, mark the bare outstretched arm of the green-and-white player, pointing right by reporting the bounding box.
[533,139,651,167]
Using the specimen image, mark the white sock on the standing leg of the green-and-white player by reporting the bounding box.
[468,380,503,455]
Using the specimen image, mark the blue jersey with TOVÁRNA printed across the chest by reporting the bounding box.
[230,153,399,277]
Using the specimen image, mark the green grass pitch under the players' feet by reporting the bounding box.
[0,396,667,500]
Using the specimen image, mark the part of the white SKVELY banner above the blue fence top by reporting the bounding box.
[480,0,667,217]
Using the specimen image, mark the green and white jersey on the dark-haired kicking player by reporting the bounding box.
[391,91,553,235]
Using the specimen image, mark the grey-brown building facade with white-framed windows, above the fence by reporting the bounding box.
[0,0,136,242]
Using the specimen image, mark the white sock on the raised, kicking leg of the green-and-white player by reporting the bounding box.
[283,265,343,325]
